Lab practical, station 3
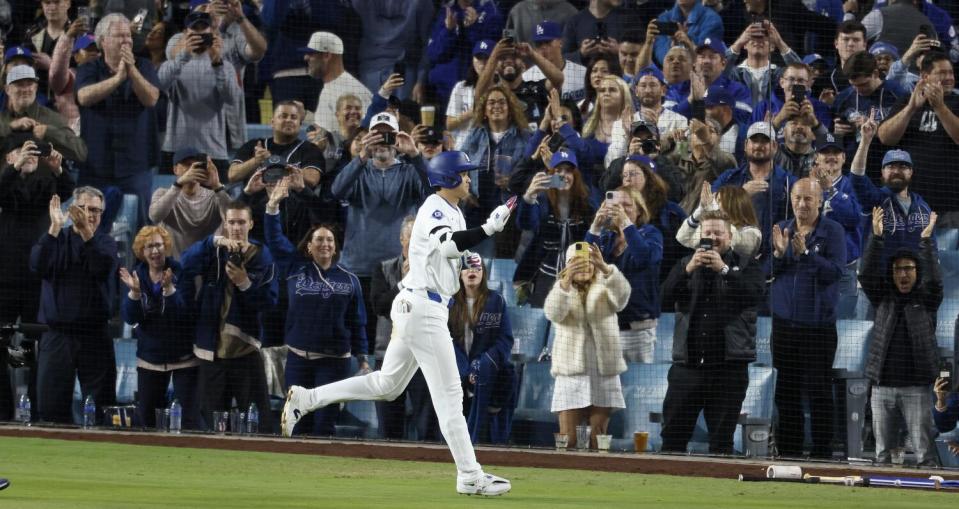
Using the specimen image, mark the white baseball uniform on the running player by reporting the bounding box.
[307,194,482,478]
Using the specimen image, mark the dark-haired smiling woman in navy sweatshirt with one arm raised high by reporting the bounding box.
[264,181,369,436]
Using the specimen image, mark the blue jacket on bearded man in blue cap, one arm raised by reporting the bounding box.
[849,173,935,262]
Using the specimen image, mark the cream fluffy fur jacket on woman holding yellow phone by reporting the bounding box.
[543,265,630,377]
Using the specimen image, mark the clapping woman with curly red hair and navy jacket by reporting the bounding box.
[120,226,200,429]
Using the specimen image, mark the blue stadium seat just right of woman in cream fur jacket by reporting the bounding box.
[611,362,671,451]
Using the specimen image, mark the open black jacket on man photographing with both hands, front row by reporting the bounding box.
[662,249,765,364]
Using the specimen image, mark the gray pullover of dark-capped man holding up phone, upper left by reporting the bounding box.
[157,51,243,159]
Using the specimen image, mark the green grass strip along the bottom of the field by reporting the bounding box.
[0,438,959,509]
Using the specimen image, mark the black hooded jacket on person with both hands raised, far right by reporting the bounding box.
[859,236,943,383]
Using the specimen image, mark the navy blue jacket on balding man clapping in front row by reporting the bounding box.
[771,217,846,326]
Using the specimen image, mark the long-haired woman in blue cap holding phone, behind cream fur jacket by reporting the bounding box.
[513,149,593,308]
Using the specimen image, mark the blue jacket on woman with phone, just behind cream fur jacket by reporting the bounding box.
[584,224,663,329]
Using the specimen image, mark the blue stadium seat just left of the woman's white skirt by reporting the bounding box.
[511,362,559,447]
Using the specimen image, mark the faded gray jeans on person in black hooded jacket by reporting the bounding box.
[872,385,938,465]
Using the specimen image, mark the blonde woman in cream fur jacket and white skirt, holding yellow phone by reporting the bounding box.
[543,242,630,448]
